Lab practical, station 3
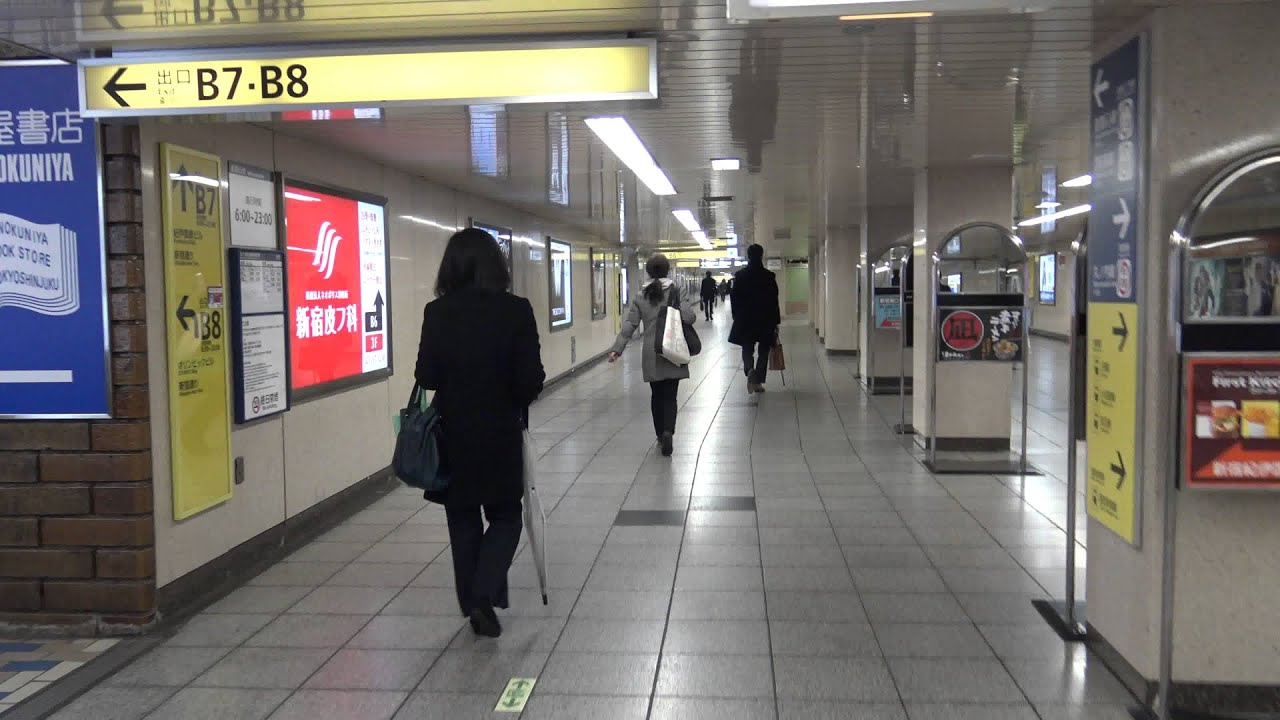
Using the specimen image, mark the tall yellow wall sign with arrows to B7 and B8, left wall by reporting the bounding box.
[160,143,232,520]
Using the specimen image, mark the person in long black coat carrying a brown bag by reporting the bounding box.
[728,245,782,395]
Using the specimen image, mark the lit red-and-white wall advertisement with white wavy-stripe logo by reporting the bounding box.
[284,181,392,391]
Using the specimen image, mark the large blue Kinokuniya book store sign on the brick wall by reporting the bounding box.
[0,61,110,418]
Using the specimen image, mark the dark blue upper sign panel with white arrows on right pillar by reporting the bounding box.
[1088,35,1147,302]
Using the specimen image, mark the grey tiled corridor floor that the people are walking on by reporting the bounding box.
[45,314,1132,720]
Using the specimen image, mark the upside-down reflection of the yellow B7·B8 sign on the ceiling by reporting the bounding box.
[76,0,653,41]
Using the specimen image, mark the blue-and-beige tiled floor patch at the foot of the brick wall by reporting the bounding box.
[0,639,116,715]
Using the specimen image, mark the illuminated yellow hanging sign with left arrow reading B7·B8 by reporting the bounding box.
[79,40,658,117]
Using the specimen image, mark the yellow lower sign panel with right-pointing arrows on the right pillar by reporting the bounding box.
[1084,302,1140,544]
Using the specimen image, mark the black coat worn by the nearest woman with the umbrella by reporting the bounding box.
[413,290,547,507]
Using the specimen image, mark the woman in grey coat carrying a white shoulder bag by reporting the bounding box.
[609,252,698,457]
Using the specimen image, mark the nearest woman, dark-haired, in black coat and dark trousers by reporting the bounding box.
[413,228,547,637]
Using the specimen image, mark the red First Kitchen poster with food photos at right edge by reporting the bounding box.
[1184,357,1280,488]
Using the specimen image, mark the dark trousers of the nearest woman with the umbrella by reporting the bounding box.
[444,500,524,615]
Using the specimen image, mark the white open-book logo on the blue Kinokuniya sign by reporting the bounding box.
[0,213,81,315]
